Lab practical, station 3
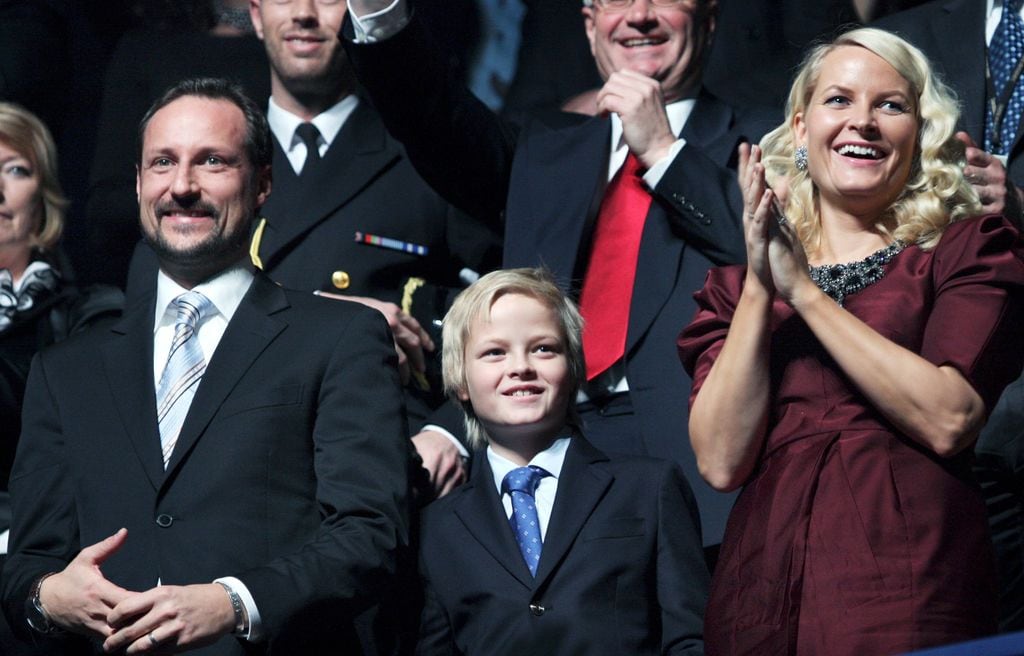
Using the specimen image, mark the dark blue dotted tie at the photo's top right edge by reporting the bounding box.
[985,0,1024,155]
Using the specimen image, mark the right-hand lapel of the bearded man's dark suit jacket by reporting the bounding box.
[158,273,288,480]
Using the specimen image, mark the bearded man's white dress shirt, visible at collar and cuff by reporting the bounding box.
[153,261,262,641]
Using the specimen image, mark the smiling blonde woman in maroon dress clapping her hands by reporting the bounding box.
[679,29,1024,656]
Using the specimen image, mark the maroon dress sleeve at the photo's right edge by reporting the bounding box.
[921,216,1024,410]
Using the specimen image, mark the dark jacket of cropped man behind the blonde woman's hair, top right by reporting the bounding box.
[872,0,1024,186]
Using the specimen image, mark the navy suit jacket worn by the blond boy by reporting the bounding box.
[417,437,708,656]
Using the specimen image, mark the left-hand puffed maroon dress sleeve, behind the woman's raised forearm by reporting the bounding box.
[676,266,746,405]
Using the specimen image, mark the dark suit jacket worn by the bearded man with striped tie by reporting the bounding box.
[3,275,408,655]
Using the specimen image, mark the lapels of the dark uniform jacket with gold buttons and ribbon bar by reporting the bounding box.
[259,101,402,267]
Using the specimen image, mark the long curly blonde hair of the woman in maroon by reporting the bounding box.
[761,28,981,251]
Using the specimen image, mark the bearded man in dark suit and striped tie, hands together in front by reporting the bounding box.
[3,80,408,656]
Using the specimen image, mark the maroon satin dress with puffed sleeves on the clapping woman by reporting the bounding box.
[679,216,1024,656]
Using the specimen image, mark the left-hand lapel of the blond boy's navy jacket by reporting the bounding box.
[455,452,544,587]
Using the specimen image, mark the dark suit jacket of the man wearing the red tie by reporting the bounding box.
[345,16,774,543]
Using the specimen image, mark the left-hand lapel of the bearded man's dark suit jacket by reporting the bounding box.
[100,292,164,489]
